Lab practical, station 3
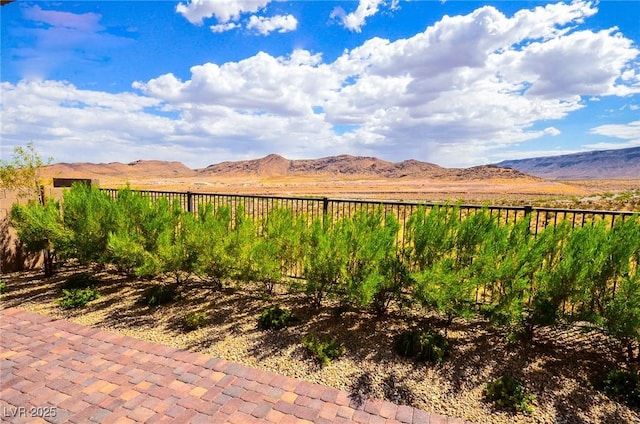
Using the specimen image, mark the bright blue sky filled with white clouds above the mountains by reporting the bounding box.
[0,0,640,168]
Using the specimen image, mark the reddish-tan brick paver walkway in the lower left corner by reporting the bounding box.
[0,308,470,424]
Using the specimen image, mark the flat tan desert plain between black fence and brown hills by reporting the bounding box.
[80,175,640,211]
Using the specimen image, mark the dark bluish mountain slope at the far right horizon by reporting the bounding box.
[496,147,640,180]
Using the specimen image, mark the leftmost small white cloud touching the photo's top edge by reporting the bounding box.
[176,0,271,25]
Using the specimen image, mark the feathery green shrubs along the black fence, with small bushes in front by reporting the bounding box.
[3,185,640,421]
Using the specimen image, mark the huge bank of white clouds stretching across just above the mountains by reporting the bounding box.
[2,2,640,166]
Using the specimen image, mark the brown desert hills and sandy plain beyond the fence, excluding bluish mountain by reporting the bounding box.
[36,155,640,210]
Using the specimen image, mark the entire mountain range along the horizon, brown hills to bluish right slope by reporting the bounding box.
[45,147,640,180]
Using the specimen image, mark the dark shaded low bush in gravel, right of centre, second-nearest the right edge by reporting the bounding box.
[394,329,451,363]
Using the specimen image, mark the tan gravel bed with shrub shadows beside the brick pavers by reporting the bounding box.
[0,267,640,424]
